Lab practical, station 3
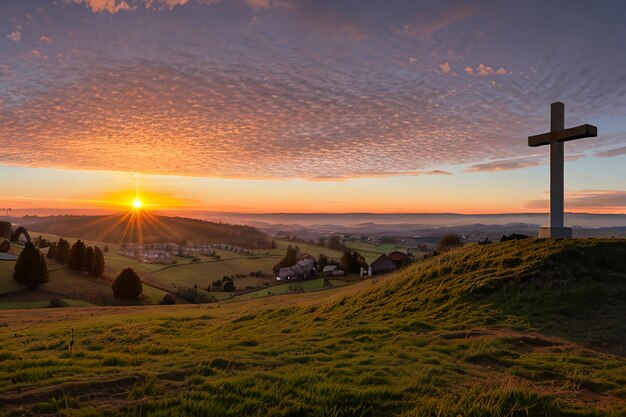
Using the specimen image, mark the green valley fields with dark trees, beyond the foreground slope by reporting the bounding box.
[0,232,341,306]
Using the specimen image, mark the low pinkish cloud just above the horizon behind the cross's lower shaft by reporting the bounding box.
[527,190,626,212]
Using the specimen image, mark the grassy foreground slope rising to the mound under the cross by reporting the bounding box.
[0,239,626,417]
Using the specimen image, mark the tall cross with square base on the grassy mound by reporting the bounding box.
[528,101,598,238]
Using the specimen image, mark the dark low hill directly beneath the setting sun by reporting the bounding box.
[19,212,272,249]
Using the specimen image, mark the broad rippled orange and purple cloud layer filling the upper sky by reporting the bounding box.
[0,0,626,180]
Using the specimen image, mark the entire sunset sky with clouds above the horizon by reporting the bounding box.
[0,0,626,213]
